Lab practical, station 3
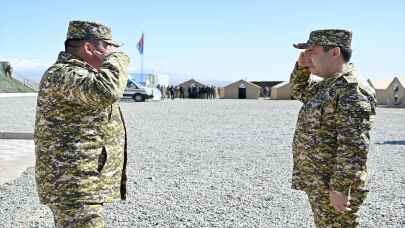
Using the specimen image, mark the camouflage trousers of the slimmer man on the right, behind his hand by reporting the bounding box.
[306,187,367,228]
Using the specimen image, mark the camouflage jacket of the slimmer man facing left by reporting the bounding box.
[290,64,376,193]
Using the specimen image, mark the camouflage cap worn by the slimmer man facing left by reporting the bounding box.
[293,29,352,49]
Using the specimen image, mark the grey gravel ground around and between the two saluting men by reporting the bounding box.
[0,98,405,227]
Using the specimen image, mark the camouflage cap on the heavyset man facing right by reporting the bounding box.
[66,21,122,47]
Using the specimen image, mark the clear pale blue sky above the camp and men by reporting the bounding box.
[0,0,405,81]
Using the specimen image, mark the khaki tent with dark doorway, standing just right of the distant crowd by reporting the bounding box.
[223,80,261,99]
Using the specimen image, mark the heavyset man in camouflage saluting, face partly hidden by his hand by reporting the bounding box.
[34,21,129,227]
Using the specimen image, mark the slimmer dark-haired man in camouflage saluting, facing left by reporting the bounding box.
[290,29,376,227]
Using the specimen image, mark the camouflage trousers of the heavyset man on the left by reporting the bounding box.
[48,204,106,228]
